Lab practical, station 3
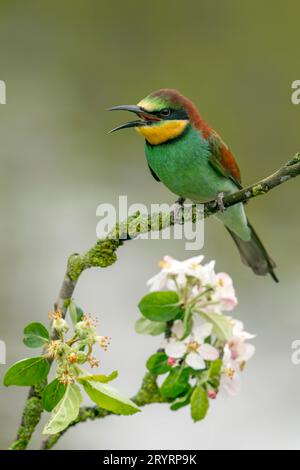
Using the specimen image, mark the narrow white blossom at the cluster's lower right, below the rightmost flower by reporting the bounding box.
[220,346,241,396]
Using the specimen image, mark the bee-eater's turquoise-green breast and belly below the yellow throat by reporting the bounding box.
[146,126,236,202]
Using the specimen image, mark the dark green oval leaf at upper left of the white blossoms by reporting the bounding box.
[139,291,183,322]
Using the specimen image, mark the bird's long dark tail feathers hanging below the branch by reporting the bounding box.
[226,222,279,282]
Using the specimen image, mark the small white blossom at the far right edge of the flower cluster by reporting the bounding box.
[227,320,255,366]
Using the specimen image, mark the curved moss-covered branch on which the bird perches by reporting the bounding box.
[10,153,300,450]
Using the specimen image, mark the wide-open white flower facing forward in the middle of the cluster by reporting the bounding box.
[164,320,219,370]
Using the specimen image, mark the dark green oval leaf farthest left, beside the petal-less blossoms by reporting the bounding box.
[3,356,50,387]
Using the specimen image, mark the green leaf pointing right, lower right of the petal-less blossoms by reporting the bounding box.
[78,378,140,415]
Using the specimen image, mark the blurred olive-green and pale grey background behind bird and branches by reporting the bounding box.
[0,0,300,449]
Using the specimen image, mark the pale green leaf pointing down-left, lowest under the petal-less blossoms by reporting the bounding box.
[43,384,82,434]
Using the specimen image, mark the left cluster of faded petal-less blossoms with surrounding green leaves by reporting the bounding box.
[3,299,140,435]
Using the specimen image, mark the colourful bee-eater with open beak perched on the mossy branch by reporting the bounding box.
[110,89,278,282]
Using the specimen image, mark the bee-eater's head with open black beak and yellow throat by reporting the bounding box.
[110,89,200,145]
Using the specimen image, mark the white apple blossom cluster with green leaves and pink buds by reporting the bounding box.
[137,256,255,421]
